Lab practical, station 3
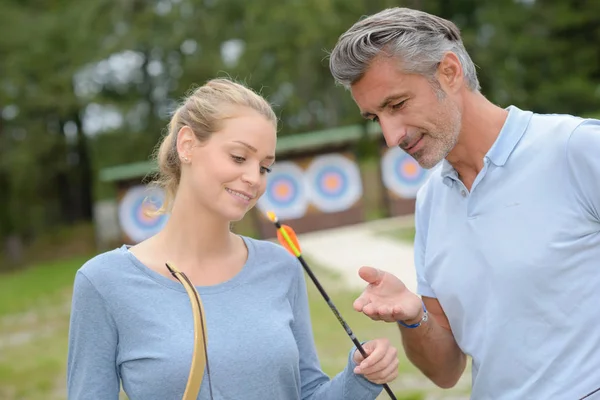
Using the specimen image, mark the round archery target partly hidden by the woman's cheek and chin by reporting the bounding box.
[256,161,308,219]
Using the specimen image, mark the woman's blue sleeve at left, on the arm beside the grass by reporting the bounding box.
[67,271,120,400]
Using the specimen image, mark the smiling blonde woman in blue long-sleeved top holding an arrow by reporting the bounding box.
[67,79,398,400]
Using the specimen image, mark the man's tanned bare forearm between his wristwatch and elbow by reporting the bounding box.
[398,297,467,389]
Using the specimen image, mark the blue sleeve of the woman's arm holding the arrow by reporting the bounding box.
[293,264,382,400]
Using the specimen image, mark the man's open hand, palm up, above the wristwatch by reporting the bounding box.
[353,267,423,324]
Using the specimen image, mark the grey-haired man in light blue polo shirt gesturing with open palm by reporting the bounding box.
[330,8,600,400]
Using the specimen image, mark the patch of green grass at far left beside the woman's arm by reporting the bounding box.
[0,258,85,400]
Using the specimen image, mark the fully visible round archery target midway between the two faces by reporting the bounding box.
[306,154,362,213]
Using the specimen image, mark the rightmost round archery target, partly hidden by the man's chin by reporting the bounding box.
[381,147,429,199]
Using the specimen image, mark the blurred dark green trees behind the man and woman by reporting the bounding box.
[0,0,600,262]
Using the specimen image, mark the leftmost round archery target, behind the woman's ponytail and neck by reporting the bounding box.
[119,186,167,242]
